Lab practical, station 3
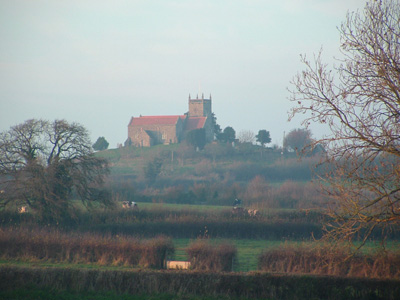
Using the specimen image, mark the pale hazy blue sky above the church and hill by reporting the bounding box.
[0,0,365,148]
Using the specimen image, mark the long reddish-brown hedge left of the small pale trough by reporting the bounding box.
[0,228,174,269]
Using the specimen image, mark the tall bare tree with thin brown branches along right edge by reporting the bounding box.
[290,0,400,246]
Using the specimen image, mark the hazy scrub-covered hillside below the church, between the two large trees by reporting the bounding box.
[97,143,321,208]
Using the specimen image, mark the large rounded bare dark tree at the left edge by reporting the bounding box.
[0,119,112,220]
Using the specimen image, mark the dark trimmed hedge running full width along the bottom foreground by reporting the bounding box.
[0,266,400,300]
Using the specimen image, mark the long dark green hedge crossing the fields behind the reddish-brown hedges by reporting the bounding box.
[0,209,322,240]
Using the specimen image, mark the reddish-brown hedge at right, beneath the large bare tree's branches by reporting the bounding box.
[258,243,400,279]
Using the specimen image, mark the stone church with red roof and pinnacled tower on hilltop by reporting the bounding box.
[125,95,214,147]
